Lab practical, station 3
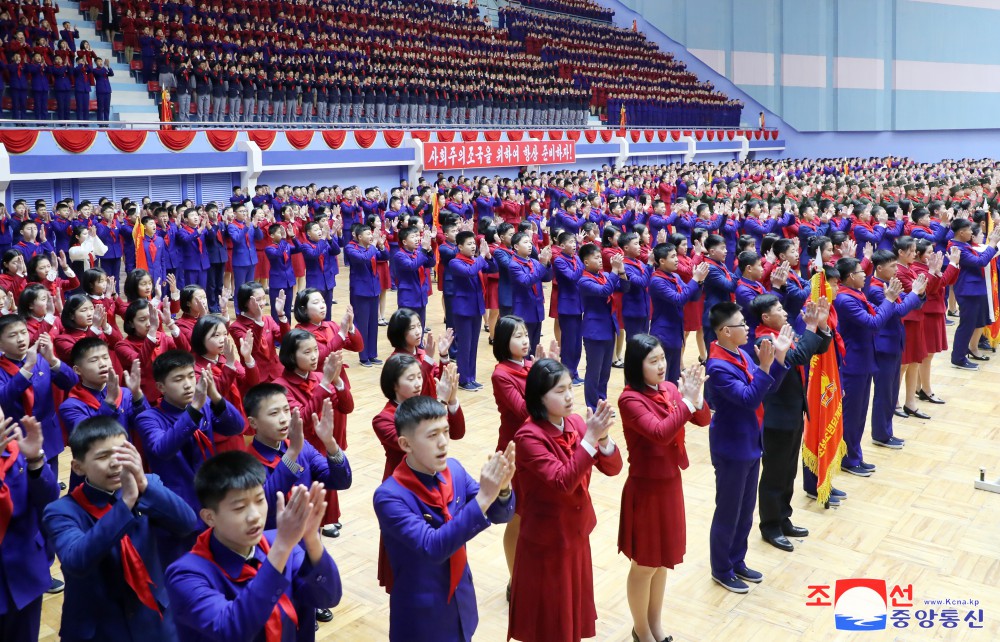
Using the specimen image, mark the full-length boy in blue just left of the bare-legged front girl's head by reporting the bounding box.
[577,240,629,410]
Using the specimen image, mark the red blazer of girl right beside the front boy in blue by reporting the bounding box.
[514,415,622,546]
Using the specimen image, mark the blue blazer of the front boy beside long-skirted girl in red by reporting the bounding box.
[374,459,515,642]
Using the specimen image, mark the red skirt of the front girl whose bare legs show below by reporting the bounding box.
[618,475,687,568]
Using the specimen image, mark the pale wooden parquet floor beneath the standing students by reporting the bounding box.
[35,274,1000,642]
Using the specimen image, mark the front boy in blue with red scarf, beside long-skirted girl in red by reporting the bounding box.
[374,396,515,642]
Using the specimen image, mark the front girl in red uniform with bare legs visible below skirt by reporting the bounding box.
[618,334,712,642]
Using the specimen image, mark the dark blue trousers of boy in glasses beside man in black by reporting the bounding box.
[709,455,760,578]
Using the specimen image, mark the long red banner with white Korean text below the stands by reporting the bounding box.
[424,140,576,171]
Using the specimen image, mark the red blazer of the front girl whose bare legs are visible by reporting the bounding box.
[618,381,712,479]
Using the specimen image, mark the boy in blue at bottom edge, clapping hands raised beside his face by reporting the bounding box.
[167,450,342,642]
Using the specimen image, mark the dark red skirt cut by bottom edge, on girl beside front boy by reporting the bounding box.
[507,537,597,642]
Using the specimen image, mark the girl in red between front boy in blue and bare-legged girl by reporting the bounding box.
[507,359,622,642]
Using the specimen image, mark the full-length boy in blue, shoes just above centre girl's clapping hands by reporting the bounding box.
[448,231,497,391]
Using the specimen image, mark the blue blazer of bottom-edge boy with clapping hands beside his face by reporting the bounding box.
[167,531,343,642]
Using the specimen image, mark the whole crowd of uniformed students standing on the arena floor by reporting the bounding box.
[0,158,1000,642]
